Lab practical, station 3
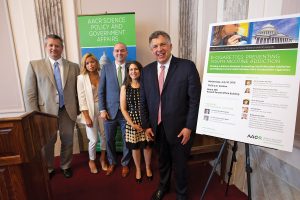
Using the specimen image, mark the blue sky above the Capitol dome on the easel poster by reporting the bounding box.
[253,17,300,41]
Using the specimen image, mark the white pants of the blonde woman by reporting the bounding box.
[85,103,106,160]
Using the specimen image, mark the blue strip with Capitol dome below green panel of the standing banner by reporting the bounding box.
[81,46,136,62]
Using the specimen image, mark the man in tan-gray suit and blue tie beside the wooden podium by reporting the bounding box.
[24,34,79,178]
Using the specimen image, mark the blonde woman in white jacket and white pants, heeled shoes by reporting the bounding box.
[77,53,107,174]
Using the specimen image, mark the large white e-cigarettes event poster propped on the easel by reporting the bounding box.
[196,15,300,151]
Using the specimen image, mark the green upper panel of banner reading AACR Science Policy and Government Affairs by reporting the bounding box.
[78,13,136,47]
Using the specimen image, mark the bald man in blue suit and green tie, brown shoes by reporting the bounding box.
[99,42,131,177]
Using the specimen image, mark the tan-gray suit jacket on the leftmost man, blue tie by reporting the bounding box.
[24,58,79,121]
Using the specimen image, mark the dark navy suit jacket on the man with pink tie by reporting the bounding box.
[141,56,201,143]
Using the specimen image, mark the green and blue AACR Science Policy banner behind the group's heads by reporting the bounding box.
[77,13,136,66]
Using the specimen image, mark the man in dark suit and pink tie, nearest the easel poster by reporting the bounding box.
[141,31,201,199]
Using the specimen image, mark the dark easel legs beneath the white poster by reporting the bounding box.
[200,139,252,200]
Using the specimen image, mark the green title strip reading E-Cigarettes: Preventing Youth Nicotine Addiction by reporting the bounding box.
[207,49,297,75]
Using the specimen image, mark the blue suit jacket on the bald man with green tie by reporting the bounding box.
[98,63,128,119]
